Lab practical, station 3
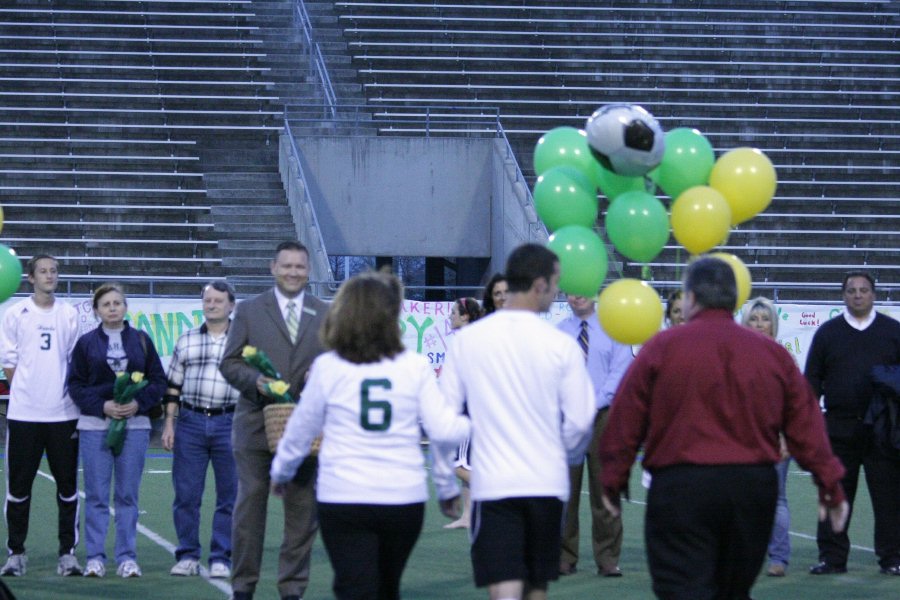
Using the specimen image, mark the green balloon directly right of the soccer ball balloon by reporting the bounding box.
[649,127,716,200]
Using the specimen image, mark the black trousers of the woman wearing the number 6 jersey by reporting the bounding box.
[319,502,425,600]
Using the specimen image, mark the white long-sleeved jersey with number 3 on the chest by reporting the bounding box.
[0,297,79,423]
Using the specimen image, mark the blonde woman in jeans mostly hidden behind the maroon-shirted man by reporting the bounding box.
[741,296,791,577]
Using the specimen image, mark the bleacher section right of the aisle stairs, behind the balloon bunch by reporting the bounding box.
[323,0,900,301]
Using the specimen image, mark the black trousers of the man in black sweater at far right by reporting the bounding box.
[816,418,900,567]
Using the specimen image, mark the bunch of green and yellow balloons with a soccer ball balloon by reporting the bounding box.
[534,104,777,344]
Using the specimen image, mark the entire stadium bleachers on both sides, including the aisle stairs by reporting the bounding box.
[0,0,900,301]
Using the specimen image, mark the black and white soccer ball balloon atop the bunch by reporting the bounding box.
[584,104,665,177]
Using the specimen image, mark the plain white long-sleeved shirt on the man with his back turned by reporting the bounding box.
[440,310,597,500]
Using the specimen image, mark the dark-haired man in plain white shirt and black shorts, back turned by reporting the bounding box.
[441,244,596,600]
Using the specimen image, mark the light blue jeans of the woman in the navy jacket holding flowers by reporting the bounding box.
[79,429,150,564]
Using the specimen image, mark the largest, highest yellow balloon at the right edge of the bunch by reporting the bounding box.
[709,148,778,225]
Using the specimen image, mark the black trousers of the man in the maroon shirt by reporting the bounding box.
[644,465,778,600]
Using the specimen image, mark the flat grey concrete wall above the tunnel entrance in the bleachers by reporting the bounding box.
[297,137,498,257]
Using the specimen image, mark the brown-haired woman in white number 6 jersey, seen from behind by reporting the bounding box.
[271,273,470,600]
